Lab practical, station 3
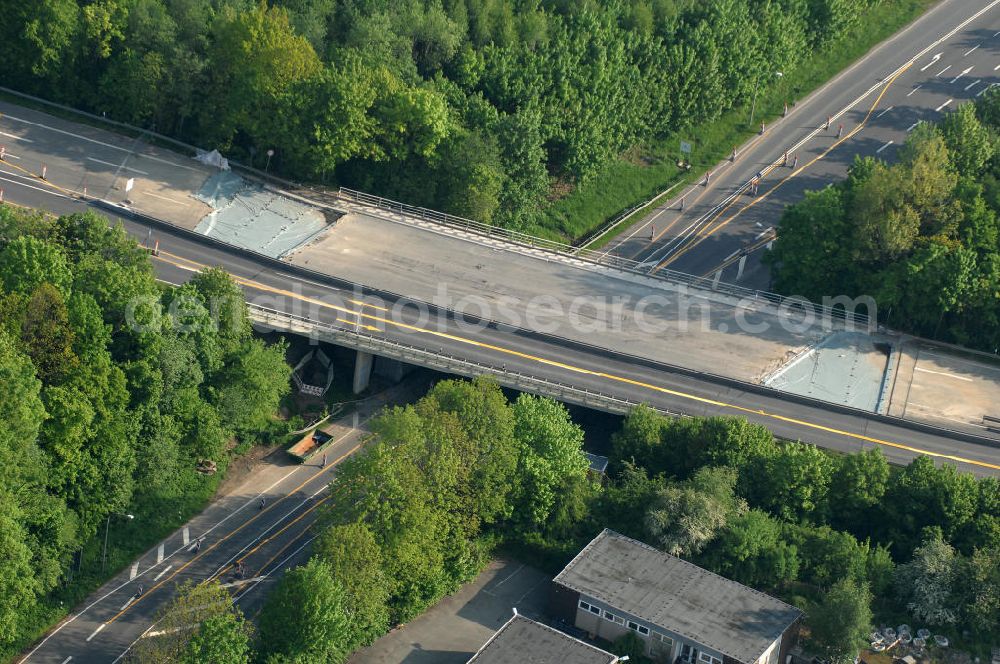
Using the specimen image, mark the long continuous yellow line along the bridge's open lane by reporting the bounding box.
[148,249,1000,470]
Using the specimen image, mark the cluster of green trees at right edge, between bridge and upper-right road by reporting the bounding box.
[766,88,1000,352]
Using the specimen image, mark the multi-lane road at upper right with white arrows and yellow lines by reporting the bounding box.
[608,0,1000,289]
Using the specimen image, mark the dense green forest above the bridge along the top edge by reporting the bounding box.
[0,0,892,235]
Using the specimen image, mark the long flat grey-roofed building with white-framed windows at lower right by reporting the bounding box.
[552,529,802,664]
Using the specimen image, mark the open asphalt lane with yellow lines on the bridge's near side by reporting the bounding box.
[1,177,1000,475]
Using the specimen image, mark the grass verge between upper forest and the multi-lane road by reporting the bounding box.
[527,0,936,244]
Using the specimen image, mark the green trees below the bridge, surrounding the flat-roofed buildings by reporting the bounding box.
[148,379,1000,664]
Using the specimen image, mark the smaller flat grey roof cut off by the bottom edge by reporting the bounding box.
[468,613,620,664]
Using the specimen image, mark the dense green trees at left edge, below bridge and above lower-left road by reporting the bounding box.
[0,205,290,657]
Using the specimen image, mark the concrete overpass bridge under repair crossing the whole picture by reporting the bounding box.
[0,94,1000,474]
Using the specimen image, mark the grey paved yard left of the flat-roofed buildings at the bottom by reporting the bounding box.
[349,560,552,664]
